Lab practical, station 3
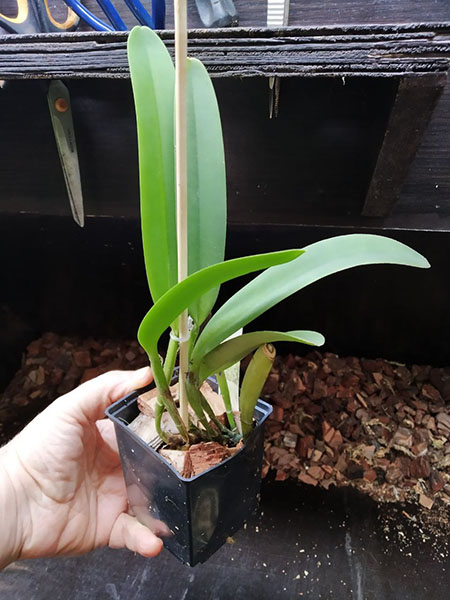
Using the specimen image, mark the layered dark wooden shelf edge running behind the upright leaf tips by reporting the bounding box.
[0,23,450,79]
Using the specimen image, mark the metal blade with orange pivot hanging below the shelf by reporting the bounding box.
[47,81,84,227]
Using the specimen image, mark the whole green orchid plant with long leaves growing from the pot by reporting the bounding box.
[128,27,429,447]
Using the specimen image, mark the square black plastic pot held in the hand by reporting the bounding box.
[106,388,272,566]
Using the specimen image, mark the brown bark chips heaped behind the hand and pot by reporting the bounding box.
[0,333,450,542]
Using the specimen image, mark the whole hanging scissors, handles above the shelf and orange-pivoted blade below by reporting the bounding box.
[0,0,84,227]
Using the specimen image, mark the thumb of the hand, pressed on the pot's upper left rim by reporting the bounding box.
[64,367,153,422]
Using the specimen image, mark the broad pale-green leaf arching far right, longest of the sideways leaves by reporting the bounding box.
[192,234,430,362]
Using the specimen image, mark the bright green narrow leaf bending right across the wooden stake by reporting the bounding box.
[138,250,302,353]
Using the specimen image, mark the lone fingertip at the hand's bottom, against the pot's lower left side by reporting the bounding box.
[109,513,163,556]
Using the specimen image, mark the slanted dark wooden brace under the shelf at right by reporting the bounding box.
[362,74,446,217]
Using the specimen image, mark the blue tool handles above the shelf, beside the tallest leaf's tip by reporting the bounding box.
[64,0,166,31]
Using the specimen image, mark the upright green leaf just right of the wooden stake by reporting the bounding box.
[187,59,227,325]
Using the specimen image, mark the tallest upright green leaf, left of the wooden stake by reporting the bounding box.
[128,27,177,302]
